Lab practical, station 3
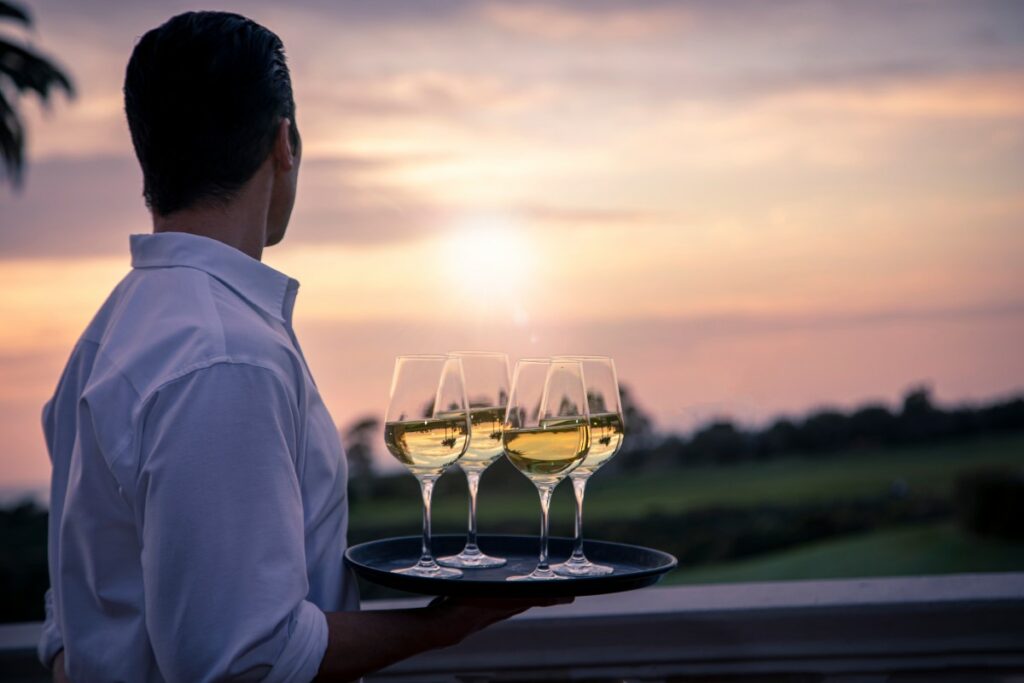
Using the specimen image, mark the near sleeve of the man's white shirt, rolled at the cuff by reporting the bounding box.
[136,362,327,683]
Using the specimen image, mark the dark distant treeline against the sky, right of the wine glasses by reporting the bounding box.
[612,387,1024,470]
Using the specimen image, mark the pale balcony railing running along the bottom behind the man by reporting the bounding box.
[0,573,1024,683]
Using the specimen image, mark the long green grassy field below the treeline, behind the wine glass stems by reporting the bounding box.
[351,434,1024,533]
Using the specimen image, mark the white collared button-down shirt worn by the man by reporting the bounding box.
[39,232,358,682]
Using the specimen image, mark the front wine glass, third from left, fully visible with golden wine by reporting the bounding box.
[502,358,590,581]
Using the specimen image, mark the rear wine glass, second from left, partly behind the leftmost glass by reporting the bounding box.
[437,351,509,569]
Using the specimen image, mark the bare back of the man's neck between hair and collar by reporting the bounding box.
[153,162,269,261]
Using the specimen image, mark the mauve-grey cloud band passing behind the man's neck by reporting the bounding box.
[0,157,456,259]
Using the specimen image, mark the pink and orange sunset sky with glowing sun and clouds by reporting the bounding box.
[0,0,1024,487]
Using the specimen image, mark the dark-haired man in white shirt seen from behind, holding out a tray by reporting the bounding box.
[39,12,557,681]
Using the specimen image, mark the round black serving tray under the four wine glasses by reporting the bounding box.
[345,533,677,598]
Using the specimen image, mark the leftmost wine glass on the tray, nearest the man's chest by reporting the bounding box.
[384,355,469,579]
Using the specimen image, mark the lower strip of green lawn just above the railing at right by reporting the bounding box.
[662,523,1024,585]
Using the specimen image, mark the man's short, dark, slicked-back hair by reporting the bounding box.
[124,12,299,215]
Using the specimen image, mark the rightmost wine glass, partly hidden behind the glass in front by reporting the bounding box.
[552,355,625,577]
